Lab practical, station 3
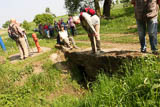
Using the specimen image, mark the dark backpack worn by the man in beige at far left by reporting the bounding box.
[9,24,19,40]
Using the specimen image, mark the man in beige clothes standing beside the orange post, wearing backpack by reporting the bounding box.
[8,19,29,60]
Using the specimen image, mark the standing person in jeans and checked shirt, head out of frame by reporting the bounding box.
[131,0,160,54]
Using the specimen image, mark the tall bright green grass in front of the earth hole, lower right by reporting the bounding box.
[80,58,160,107]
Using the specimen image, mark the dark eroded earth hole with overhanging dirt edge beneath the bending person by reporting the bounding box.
[55,49,158,88]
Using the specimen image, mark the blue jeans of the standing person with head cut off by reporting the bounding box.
[136,18,158,51]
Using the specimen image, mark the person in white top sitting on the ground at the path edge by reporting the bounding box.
[59,24,78,49]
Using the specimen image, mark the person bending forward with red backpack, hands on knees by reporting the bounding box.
[73,7,102,54]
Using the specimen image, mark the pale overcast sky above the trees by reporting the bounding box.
[0,0,66,28]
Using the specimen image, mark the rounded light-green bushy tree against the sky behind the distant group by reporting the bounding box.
[33,14,53,25]
